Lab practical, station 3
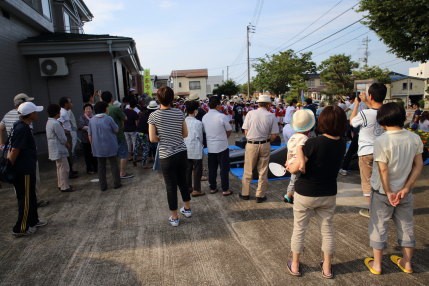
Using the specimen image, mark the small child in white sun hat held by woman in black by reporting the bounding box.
[283,109,316,204]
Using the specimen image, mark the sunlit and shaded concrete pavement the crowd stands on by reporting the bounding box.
[0,142,429,286]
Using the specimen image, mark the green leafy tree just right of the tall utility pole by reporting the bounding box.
[253,50,316,95]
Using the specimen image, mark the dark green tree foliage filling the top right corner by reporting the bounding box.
[359,0,429,62]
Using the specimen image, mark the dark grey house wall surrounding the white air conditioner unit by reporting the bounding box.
[27,53,114,153]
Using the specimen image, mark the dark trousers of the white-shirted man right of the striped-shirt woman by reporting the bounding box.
[208,148,229,192]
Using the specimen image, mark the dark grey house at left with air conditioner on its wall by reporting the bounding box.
[0,0,142,152]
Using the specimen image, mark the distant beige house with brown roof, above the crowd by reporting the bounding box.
[170,69,208,99]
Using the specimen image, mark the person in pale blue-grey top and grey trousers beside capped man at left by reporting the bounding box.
[46,104,73,192]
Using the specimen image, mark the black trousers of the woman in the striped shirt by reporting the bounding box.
[160,151,191,211]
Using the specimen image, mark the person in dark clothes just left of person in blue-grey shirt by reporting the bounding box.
[78,103,98,174]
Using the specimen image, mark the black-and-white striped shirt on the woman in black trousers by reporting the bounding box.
[147,108,186,159]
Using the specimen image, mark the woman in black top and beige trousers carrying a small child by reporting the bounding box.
[287,106,347,279]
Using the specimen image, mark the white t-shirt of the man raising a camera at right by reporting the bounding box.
[352,108,384,156]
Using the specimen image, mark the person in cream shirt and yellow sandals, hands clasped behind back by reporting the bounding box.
[364,102,423,274]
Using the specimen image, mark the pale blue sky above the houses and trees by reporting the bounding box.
[84,0,418,83]
